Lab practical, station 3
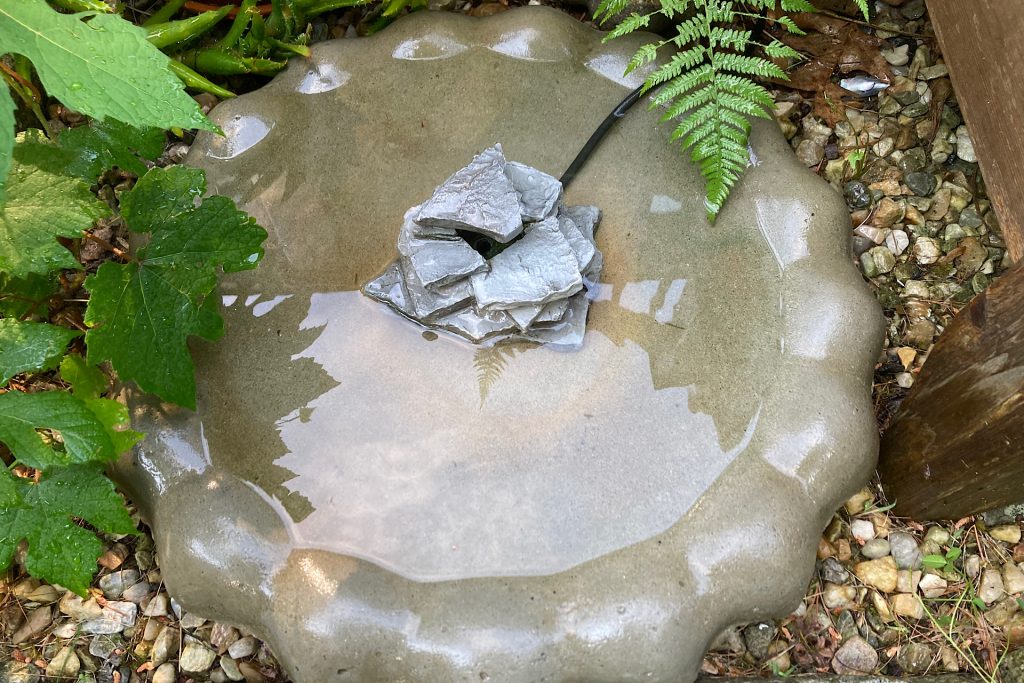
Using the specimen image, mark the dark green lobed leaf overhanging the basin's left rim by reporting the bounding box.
[85,167,266,408]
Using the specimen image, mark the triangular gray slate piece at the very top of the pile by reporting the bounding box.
[416,144,522,244]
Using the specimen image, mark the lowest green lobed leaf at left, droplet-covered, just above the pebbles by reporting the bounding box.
[0,466,136,595]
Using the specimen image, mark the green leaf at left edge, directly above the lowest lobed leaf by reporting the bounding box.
[0,391,118,470]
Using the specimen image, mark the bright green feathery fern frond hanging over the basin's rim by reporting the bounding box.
[594,0,868,221]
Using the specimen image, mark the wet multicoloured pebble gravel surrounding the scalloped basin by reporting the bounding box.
[0,0,1024,683]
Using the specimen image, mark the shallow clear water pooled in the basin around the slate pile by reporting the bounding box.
[178,40,782,581]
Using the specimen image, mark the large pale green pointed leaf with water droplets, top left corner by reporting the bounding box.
[0,0,216,135]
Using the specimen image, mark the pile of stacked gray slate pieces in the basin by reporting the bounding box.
[362,144,602,349]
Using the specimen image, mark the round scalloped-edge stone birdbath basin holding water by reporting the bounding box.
[118,7,882,683]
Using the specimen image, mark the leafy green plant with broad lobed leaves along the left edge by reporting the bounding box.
[0,0,266,594]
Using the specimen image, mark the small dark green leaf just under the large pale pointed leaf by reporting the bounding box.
[57,120,165,182]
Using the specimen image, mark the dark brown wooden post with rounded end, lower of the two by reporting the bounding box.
[879,267,1024,519]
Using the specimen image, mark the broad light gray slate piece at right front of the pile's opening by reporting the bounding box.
[471,217,583,309]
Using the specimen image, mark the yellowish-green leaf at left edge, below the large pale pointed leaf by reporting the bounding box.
[0,156,110,278]
